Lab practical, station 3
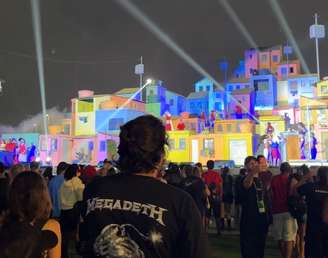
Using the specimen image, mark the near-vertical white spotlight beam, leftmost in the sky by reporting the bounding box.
[31,0,48,141]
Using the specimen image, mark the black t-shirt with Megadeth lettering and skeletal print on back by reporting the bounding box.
[80,174,208,258]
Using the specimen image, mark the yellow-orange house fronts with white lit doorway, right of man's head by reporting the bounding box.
[167,119,257,165]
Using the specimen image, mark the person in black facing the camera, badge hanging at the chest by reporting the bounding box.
[240,156,269,258]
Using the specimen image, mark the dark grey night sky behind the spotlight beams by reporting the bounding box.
[0,0,328,125]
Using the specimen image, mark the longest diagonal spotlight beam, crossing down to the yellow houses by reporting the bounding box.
[115,0,259,122]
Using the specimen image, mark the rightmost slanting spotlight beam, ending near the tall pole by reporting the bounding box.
[269,0,310,73]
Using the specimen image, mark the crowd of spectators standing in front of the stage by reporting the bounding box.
[0,116,328,258]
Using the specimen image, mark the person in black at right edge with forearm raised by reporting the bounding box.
[296,167,328,258]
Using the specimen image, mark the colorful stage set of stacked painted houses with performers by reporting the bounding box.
[1,46,328,165]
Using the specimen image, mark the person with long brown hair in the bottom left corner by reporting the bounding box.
[0,171,61,258]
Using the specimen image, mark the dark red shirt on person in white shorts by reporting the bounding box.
[271,175,288,214]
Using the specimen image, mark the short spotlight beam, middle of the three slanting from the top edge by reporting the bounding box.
[218,0,258,49]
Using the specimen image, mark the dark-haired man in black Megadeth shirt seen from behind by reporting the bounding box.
[79,116,208,258]
